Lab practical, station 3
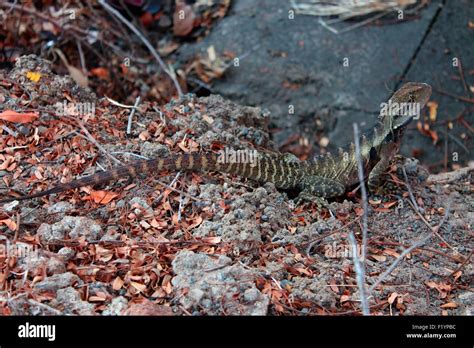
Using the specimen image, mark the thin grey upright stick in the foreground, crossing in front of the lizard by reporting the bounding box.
[349,123,370,315]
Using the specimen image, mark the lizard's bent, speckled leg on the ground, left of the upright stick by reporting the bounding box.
[296,175,346,207]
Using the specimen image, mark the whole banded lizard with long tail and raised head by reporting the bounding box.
[0,82,431,205]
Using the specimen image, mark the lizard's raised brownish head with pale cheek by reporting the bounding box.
[380,82,431,130]
